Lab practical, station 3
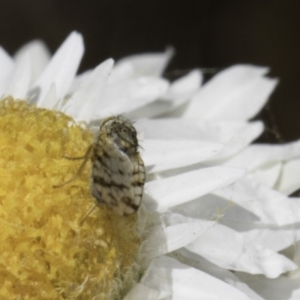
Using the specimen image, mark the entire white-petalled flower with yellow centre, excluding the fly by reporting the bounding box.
[0,32,300,300]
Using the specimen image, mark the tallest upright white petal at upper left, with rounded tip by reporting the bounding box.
[32,32,84,108]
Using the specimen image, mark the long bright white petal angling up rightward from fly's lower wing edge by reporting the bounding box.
[145,167,245,212]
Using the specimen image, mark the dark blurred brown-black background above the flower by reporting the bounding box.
[0,0,300,142]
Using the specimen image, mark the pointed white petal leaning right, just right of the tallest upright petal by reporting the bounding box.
[63,59,114,122]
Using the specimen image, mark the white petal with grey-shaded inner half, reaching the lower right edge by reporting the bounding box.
[177,199,300,252]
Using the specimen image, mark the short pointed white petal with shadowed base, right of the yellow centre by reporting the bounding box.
[143,221,214,259]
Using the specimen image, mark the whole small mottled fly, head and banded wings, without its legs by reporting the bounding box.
[91,116,145,215]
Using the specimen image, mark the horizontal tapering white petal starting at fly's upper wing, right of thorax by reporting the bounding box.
[141,140,222,172]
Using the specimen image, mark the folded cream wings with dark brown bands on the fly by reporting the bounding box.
[92,137,145,215]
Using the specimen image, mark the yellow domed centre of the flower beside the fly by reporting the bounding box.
[0,98,139,300]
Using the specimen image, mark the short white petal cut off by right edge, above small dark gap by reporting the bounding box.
[276,159,300,195]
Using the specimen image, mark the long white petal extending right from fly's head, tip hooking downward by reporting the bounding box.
[136,118,263,159]
